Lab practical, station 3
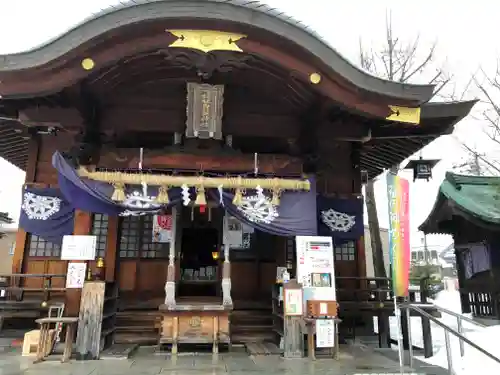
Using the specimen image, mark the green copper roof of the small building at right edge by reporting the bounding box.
[419,172,500,233]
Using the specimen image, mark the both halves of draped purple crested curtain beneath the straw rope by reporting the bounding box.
[52,152,317,236]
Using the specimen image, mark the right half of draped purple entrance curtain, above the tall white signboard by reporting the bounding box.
[210,179,317,236]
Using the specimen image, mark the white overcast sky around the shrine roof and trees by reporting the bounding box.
[0,0,494,251]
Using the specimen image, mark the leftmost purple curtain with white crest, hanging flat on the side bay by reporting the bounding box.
[19,187,75,245]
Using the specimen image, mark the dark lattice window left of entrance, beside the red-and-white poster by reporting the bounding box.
[119,215,170,259]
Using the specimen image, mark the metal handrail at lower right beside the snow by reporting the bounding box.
[398,303,500,375]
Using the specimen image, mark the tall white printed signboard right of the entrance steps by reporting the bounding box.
[295,236,336,303]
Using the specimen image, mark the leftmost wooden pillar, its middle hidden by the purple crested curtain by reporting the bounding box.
[12,137,40,273]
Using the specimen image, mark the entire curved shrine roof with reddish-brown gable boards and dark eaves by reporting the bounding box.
[0,0,475,177]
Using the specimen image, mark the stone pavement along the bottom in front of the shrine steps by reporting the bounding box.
[0,347,430,375]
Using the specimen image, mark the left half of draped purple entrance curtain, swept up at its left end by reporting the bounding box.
[52,152,180,216]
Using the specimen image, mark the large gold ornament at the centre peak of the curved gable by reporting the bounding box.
[166,30,246,53]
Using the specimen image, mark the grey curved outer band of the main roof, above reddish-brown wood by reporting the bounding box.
[0,0,434,105]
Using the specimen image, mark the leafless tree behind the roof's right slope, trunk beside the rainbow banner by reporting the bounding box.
[359,13,450,277]
